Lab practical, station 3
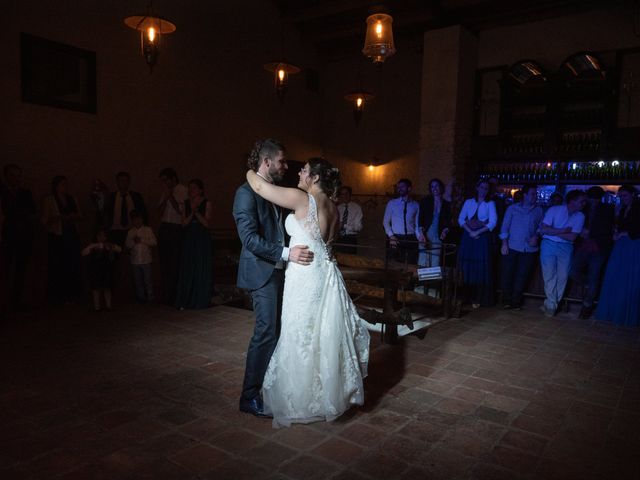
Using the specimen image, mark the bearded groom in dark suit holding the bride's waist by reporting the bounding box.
[233,139,313,417]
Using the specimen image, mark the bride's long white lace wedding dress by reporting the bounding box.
[262,195,369,426]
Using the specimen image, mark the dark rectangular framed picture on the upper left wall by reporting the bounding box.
[20,33,97,113]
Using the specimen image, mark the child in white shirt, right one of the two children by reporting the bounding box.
[125,210,158,303]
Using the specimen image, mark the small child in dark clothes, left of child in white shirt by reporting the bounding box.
[82,229,122,312]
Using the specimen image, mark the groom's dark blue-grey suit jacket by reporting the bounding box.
[233,183,285,290]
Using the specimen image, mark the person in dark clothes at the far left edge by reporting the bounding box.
[0,164,36,310]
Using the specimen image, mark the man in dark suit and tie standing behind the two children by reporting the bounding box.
[105,172,149,247]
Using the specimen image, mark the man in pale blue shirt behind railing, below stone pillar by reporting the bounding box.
[382,178,420,265]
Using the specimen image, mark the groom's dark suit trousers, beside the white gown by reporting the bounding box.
[240,269,284,401]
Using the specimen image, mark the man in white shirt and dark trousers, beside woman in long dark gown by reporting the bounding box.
[158,168,188,305]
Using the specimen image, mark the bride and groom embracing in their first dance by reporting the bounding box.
[233,139,369,426]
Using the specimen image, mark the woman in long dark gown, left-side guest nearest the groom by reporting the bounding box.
[175,179,213,310]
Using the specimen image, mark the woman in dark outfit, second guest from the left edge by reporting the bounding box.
[42,175,82,305]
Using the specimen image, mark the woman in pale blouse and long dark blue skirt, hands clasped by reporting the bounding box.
[458,180,498,308]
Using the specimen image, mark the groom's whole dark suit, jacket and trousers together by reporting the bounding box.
[233,183,284,402]
